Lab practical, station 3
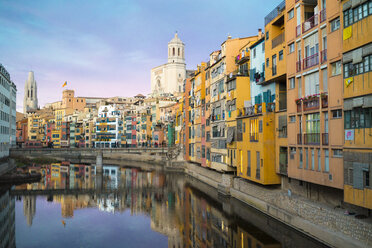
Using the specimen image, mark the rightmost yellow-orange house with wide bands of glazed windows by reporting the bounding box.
[340,0,372,209]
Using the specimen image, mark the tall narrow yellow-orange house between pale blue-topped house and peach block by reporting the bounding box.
[262,1,288,183]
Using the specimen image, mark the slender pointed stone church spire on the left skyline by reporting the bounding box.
[23,71,38,114]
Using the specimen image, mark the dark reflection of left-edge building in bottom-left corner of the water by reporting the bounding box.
[0,189,16,248]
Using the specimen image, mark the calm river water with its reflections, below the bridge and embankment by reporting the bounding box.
[0,162,325,248]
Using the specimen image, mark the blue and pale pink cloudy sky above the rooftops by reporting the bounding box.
[0,0,281,111]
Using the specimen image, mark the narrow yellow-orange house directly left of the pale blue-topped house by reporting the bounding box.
[225,35,262,170]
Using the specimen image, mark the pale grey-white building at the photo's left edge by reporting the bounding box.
[0,64,17,158]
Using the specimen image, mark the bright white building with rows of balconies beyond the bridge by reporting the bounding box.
[95,105,123,148]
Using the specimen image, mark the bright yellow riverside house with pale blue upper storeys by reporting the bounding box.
[237,37,280,185]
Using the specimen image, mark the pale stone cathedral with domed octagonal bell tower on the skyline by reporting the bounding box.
[151,33,186,96]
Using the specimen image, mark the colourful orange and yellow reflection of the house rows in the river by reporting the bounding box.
[9,163,326,248]
